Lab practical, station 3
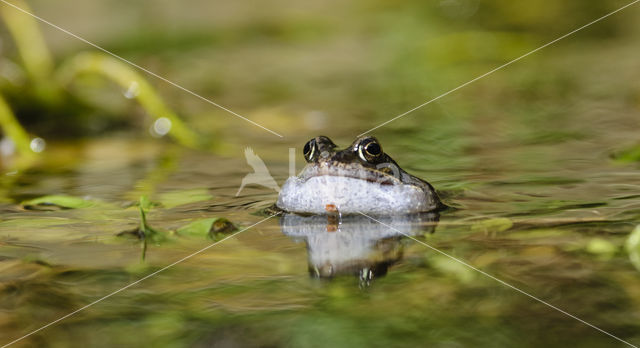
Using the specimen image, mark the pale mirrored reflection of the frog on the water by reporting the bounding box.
[280,212,438,285]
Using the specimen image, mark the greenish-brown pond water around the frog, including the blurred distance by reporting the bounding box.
[0,1,640,347]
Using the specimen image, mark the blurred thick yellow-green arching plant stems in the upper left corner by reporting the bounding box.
[0,1,209,169]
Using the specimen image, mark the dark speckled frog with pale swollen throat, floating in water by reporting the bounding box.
[276,136,444,215]
